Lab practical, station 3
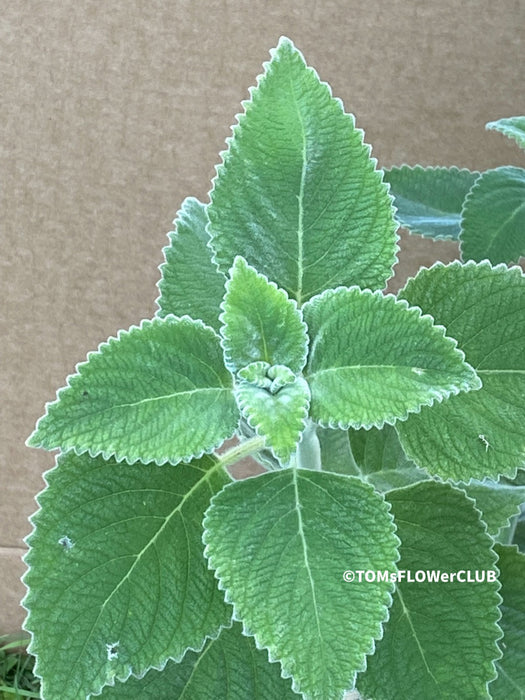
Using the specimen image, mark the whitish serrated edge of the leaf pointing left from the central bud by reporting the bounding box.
[25,314,237,466]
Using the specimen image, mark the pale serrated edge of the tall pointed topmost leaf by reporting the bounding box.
[206,35,400,299]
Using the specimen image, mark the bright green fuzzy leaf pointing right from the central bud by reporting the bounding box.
[304,288,480,428]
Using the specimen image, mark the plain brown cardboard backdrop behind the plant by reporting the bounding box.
[0,0,525,633]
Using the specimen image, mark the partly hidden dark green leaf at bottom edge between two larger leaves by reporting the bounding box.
[96,623,297,700]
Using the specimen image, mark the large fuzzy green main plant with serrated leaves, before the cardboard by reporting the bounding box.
[24,38,525,700]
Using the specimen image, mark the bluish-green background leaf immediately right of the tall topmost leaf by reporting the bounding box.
[385,165,479,240]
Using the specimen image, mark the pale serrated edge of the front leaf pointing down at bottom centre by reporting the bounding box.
[202,467,401,700]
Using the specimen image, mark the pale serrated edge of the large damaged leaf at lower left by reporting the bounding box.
[20,450,234,700]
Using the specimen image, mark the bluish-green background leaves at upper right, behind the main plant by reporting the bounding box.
[385,117,525,264]
